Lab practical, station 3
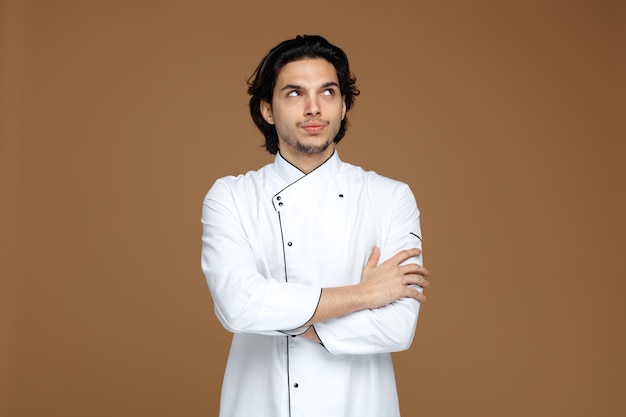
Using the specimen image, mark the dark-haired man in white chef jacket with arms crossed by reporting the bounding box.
[202,36,429,417]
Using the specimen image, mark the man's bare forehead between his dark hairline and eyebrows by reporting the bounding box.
[276,58,339,88]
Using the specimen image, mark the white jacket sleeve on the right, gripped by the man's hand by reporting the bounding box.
[314,185,422,354]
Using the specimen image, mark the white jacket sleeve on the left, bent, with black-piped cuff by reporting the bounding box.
[201,179,321,336]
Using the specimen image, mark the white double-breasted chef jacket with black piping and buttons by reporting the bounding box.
[202,151,421,417]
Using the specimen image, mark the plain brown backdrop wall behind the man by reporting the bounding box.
[0,0,626,417]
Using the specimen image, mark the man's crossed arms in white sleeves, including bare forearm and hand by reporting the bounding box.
[202,179,429,354]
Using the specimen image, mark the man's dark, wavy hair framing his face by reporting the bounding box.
[248,35,360,155]
